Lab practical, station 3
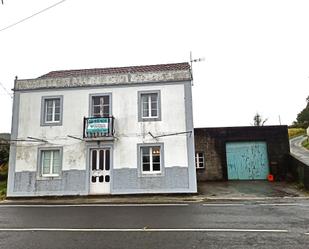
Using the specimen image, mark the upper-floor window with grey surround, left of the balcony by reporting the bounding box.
[41,96,63,125]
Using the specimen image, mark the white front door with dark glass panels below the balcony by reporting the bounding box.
[90,148,111,195]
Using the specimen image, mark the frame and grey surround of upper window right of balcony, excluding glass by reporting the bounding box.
[138,90,161,122]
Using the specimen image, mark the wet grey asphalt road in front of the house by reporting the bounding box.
[0,200,309,249]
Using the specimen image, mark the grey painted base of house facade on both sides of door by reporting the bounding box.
[8,166,196,197]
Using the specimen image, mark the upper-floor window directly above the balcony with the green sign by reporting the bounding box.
[90,95,111,117]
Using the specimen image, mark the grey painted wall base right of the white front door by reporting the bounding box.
[111,166,194,194]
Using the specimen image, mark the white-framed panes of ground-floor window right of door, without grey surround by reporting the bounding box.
[140,146,161,174]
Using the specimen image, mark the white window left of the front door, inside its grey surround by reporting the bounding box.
[40,149,61,177]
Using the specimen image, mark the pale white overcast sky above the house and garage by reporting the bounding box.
[0,0,309,132]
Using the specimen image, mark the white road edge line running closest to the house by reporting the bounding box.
[0,203,189,208]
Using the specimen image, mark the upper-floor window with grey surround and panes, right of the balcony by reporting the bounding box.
[138,91,161,121]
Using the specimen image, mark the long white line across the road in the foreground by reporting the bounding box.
[0,228,289,233]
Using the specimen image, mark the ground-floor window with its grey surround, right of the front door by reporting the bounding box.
[138,144,163,175]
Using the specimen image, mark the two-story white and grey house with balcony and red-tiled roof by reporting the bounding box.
[7,63,197,196]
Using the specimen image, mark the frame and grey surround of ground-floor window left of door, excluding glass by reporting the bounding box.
[38,147,62,179]
